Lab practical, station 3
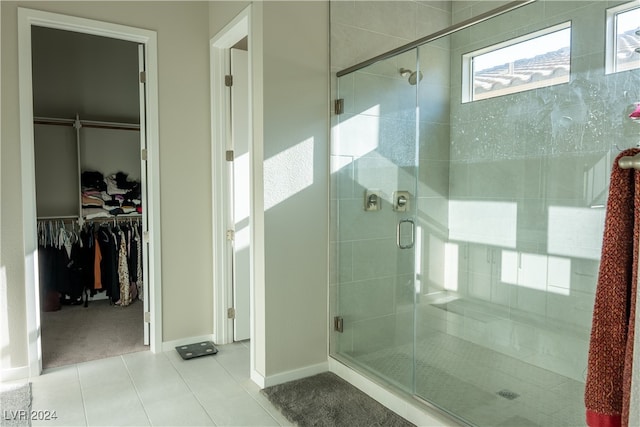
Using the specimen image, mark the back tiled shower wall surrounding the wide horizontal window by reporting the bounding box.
[449,1,640,380]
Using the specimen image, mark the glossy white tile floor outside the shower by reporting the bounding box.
[21,343,291,426]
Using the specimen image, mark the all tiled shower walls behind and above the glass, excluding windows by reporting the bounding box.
[330,1,640,380]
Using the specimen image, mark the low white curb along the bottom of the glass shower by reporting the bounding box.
[329,357,461,427]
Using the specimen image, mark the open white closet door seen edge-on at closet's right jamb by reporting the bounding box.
[138,44,151,345]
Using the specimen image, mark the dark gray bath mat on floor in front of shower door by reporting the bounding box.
[262,372,413,427]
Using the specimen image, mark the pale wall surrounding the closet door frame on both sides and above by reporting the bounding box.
[0,1,213,369]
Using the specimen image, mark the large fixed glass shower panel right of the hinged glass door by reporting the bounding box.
[415,2,640,426]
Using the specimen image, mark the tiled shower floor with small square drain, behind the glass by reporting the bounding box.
[354,332,585,427]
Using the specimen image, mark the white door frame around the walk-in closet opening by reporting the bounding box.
[18,7,162,376]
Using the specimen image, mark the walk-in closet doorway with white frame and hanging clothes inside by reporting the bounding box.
[19,9,161,375]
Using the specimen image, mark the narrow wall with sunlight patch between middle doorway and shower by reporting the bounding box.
[209,1,329,382]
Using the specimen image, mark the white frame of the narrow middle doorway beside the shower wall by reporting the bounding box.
[209,2,266,387]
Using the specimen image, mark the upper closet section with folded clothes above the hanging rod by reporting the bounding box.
[34,115,142,223]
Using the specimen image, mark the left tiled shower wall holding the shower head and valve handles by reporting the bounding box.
[330,1,524,362]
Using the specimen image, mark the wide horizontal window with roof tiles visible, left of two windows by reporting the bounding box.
[462,22,571,102]
